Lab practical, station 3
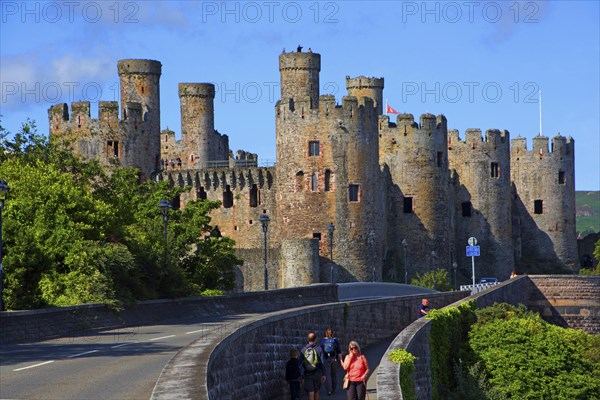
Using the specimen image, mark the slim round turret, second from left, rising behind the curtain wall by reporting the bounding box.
[179,83,215,169]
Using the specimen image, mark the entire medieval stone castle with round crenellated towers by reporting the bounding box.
[48,48,578,290]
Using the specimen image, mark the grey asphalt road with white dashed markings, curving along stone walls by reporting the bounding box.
[0,314,252,400]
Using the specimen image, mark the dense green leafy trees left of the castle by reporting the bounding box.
[0,120,242,309]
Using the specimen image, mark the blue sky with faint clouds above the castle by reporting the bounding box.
[0,0,600,190]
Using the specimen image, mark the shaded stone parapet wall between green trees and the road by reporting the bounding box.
[0,284,337,344]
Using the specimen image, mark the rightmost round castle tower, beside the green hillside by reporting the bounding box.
[511,135,578,268]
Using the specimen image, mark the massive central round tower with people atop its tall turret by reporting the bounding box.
[275,53,384,282]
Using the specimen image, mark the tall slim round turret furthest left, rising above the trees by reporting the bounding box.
[117,59,162,178]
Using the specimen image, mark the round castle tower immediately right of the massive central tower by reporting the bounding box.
[379,114,452,281]
